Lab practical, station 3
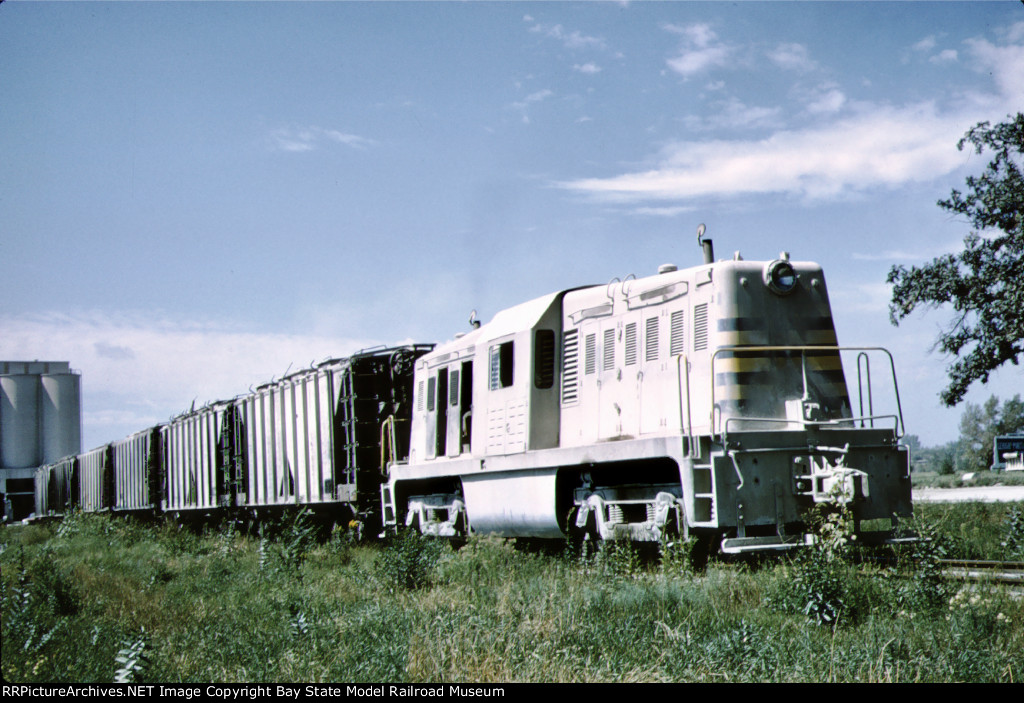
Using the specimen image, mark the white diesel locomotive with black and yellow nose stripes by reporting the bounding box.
[382,248,911,552]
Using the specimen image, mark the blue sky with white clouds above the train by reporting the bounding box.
[0,0,1024,449]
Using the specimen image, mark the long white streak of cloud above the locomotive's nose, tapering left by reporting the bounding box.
[557,103,963,202]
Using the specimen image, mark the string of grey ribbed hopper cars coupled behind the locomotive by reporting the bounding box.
[36,345,431,528]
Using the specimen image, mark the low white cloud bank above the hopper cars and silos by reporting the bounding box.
[0,312,380,448]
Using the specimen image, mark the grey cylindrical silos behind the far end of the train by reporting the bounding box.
[0,361,82,520]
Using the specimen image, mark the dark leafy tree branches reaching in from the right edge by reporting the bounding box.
[888,113,1024,406]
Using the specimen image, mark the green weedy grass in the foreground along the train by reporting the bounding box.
[0,503,1024,683]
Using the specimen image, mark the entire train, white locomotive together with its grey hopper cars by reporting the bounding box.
[36,230,911,553]
